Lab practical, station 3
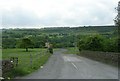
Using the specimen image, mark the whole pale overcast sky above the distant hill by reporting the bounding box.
[0,0,119,28]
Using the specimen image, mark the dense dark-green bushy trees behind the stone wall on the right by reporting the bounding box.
[77,34,118,52]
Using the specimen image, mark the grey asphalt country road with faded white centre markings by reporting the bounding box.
[22,49,118,79]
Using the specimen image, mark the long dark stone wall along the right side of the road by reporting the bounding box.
[79,50,120,66]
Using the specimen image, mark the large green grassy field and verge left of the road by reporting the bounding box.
[2,49,51,78]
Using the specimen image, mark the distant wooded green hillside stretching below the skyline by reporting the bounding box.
[2,26,117,48]
